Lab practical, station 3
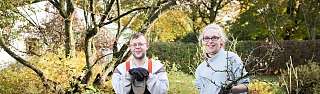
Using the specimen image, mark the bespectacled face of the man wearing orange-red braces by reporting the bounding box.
[130,35,148,59]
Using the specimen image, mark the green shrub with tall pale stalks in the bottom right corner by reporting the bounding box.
[281,62,320,94]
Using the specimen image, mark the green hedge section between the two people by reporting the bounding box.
[148,42,200,73]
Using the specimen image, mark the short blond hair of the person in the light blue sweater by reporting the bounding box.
[199,23,228,44]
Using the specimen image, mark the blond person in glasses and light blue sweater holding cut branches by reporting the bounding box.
[195,24,249,94]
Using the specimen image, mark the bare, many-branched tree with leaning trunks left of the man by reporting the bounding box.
[0,0,176,93]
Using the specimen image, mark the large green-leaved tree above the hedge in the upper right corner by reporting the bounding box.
[230,0,319,40]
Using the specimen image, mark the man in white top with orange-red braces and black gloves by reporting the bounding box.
[112,33,169,94]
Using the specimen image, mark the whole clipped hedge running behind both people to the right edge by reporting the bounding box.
[149,40,320,74]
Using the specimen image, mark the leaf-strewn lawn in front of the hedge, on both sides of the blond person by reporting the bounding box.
[168,71,285,94]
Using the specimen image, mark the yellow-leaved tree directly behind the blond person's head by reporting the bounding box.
[171,0,239,42]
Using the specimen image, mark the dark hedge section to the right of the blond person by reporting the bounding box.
[237,40,320,74]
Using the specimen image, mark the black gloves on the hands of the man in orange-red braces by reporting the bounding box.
[129,68,149,81]
